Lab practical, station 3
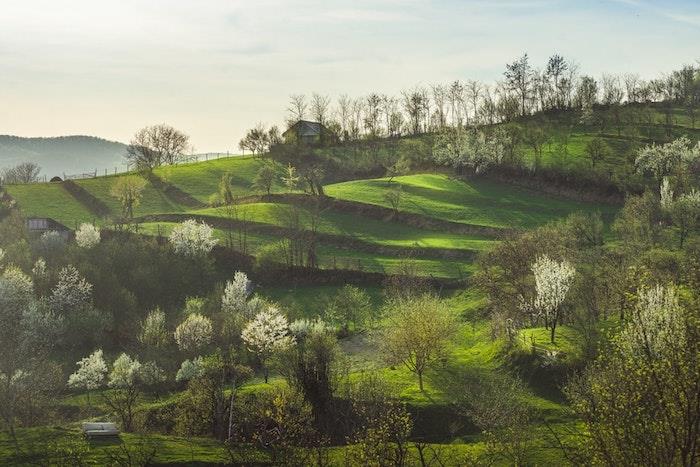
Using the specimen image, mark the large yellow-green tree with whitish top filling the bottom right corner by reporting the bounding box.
[565,285,700,465]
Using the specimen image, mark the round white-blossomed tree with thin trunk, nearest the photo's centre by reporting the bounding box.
[241,306,294,383]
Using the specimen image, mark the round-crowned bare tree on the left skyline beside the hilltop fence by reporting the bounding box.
[126,124,191,171]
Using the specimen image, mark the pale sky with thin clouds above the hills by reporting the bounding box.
[0,0,700,152]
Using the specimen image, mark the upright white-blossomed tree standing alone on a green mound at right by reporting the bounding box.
[532,255,576,343]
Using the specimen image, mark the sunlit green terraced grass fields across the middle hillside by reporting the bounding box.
[8,152,615,279]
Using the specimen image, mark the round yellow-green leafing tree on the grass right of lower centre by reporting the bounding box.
[383,295,456,391]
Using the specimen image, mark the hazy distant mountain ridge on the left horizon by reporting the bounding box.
[0,135,126,178]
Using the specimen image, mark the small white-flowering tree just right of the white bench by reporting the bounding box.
[104,353,143,431]
